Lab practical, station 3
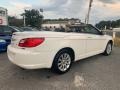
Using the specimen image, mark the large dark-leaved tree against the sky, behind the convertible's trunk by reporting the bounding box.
[24,9,43,28]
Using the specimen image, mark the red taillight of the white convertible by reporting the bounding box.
[19,38,45,48]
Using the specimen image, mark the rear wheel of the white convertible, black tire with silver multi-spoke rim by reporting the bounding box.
[52,50,73,74]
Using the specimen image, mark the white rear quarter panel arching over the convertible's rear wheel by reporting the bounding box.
[33,36,86,60]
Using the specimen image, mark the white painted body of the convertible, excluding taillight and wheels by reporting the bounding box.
[7,28,112,69]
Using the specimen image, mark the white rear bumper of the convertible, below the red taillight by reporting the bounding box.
[7,45,53,69]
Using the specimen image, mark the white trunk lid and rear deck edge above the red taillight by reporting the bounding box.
[11,31,67,48]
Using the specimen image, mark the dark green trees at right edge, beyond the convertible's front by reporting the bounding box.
[95,19,120,30]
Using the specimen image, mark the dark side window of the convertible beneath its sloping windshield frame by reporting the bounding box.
[84,25,100,35]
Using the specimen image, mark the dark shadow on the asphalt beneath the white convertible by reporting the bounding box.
[12,54,104,79]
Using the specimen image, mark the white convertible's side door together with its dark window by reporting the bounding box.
[84,25,106,55]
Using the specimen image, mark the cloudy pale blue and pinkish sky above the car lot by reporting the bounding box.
[0,0,120,24]
